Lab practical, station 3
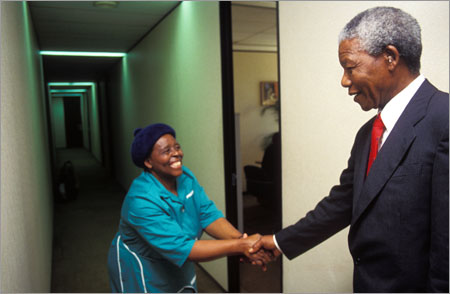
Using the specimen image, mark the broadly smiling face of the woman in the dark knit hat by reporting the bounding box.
[144,134,183,180]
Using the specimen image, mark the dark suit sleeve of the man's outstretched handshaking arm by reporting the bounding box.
[275,136,358,259]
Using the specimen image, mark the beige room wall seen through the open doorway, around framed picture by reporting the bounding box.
[233,52,279,190]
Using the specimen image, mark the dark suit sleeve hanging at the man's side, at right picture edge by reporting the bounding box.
[428,112,449,293]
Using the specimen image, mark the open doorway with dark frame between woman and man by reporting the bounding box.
[221,1,282,293]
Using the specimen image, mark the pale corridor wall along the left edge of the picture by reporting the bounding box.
[0,1,53,293]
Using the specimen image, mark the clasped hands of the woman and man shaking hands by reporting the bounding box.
[241,233,281,271]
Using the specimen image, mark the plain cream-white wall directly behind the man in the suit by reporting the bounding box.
[279,1,449,292]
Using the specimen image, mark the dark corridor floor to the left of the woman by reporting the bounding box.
[51,148,124,292]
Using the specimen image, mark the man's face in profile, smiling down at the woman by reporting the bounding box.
[339,39,395,111]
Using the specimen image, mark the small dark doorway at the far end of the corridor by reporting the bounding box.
[64,97,83,148]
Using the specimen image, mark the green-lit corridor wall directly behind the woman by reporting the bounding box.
[107,1,227,289]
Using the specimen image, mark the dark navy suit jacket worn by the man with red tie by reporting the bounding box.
[275,80,449,292]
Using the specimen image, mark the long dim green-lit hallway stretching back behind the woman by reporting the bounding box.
[1,1,280,293]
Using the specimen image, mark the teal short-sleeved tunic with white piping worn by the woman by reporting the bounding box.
[108,166,223,293]
